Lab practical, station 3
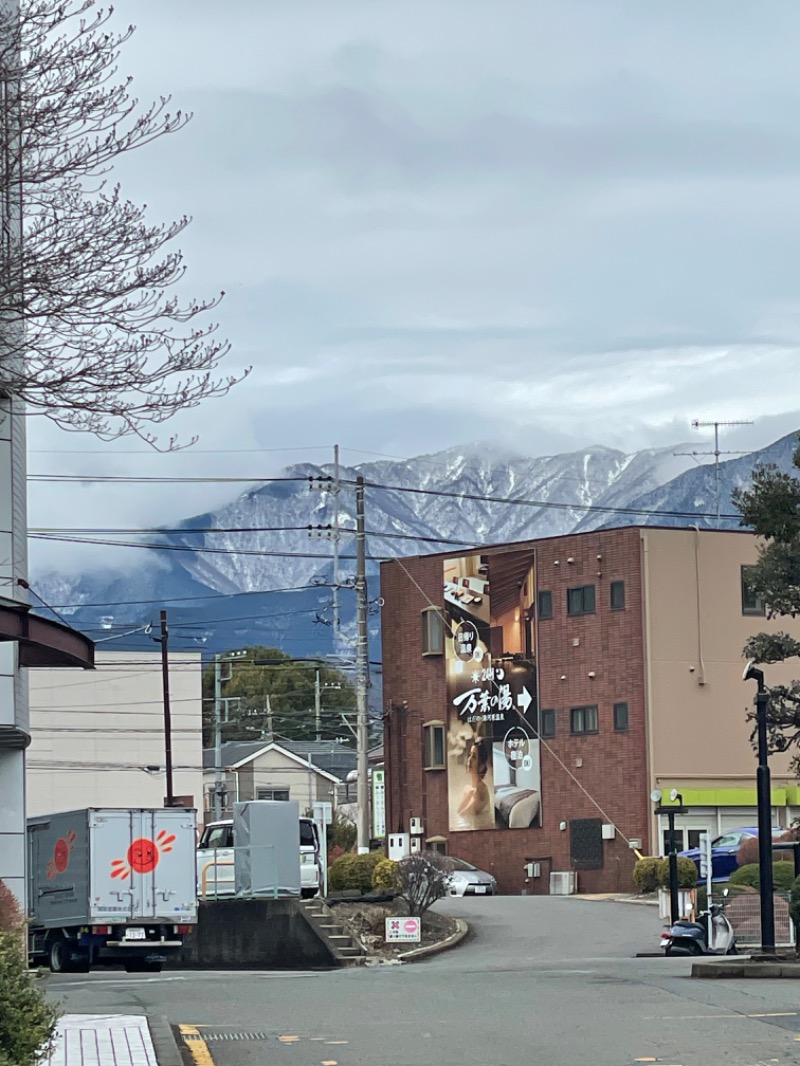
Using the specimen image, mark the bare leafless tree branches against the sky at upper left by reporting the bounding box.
[0,0,246,442]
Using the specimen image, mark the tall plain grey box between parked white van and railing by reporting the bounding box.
[234,800,301,898]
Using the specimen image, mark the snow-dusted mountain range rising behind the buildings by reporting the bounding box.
[34,428,796,655]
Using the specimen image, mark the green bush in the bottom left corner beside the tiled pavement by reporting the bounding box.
[0,931,58,1066]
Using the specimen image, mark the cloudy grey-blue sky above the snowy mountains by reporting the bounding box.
[30,0,800,575]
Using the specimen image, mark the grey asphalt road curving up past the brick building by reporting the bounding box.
[49,897,800,1066]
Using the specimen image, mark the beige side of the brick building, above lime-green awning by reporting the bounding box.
[641,529,800,847]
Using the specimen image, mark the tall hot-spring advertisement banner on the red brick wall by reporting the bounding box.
[443,550,541,831]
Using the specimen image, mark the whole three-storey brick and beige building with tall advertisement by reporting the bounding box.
[381,527,800,893]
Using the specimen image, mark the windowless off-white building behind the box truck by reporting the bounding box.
[28,645,203,814]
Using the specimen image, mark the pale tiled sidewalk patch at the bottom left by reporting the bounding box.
[43,1014,167,1066]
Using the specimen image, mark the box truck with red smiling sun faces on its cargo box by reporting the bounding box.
[28,807,197,973]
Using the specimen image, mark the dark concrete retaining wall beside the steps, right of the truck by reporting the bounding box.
[169,900,339,970]
